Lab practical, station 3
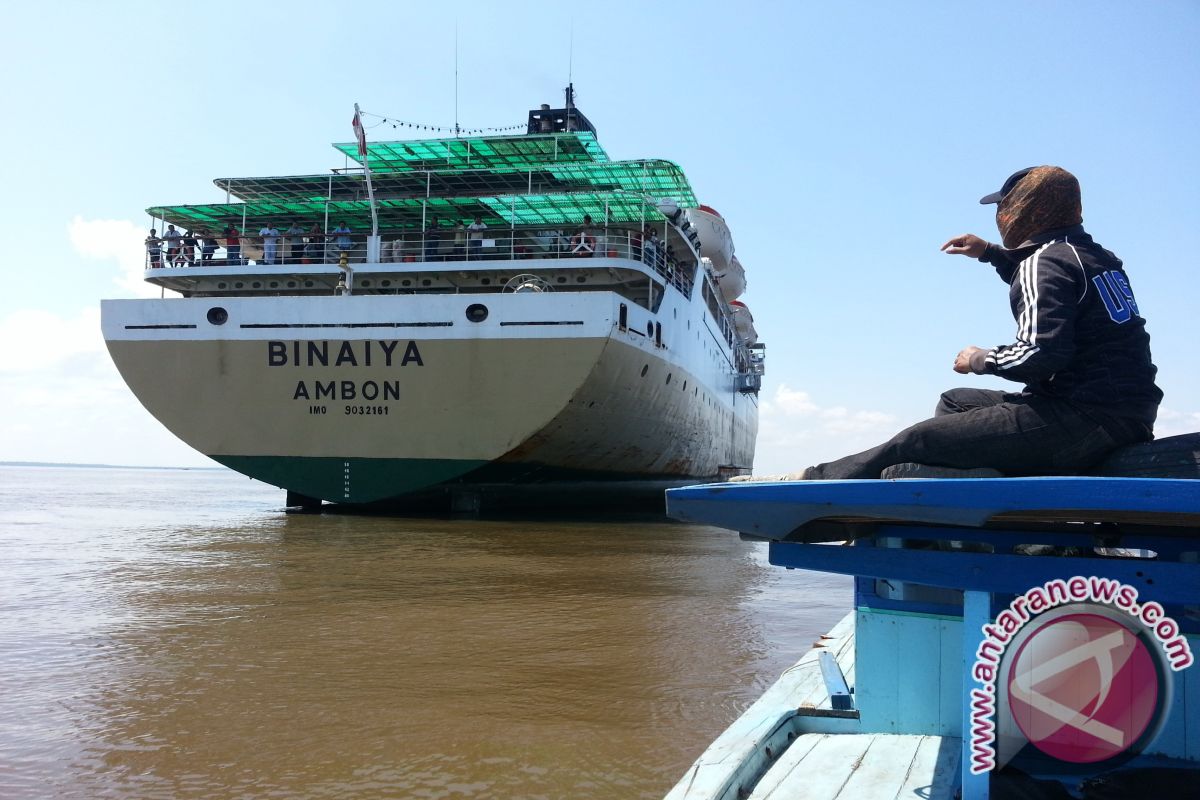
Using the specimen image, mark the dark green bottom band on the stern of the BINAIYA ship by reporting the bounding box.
[218,456,487,503]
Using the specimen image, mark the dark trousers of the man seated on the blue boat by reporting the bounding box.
[811,389,1153,480]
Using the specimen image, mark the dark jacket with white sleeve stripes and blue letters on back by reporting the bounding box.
[971,225,1163,428]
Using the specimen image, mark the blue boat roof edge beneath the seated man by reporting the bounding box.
[667,477,1200,540]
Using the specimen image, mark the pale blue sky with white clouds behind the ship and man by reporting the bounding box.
[0,0,1200,471]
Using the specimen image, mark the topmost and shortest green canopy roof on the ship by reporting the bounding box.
[334,131,608,172]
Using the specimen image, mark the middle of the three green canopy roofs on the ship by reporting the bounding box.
[214,160,696,207]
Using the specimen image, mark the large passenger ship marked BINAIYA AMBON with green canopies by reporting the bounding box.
[102,89,763,509]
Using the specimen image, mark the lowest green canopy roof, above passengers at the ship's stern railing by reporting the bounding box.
[146,192,662,234]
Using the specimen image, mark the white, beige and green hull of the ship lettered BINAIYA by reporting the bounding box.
[103,291,757,505]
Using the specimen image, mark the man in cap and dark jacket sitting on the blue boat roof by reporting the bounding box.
[742,167,1163,480]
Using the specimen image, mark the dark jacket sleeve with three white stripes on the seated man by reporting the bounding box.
[985,242,1080,383]
